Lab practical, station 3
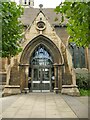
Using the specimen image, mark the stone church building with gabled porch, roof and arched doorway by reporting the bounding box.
[0,0,90,95]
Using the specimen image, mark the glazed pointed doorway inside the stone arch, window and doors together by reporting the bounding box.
[29,44,54,92]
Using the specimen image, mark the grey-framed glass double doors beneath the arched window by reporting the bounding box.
[32,68,51,92]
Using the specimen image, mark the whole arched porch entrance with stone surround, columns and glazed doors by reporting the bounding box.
[20,35,62,92]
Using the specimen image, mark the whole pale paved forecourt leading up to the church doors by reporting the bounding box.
[2,93,88,118]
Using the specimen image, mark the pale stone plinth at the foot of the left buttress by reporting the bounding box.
[3,85,21,96]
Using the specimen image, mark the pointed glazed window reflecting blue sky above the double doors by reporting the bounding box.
[31,45,53,66]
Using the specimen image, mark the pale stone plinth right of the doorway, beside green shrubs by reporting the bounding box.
[61,85,80,96]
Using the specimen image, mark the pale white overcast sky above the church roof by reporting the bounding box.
[15,0,63,8]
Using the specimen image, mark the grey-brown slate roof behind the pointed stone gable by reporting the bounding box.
[21,8,67,25]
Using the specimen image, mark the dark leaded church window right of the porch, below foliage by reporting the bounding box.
[69,42,86,68]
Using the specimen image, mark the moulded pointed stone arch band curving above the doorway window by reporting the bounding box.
[20,35,63,64]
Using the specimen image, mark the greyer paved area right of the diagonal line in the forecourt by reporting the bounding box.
[62,95,88,118]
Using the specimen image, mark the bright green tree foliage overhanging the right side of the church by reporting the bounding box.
[55,1,90,46]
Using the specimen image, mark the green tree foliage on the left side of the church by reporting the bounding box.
[0,2,23,57]
